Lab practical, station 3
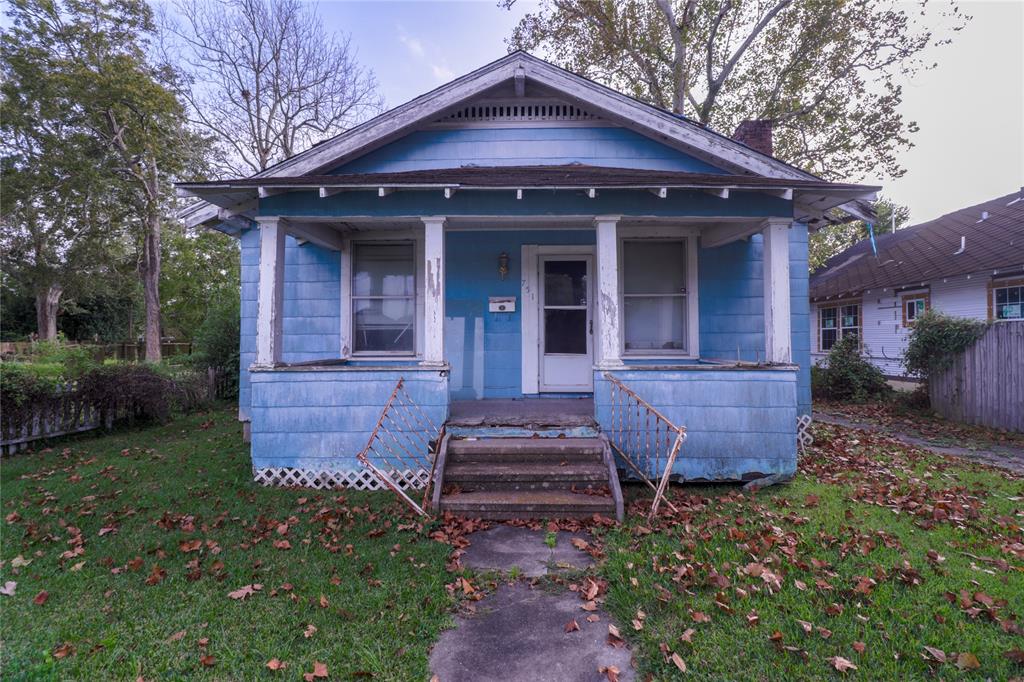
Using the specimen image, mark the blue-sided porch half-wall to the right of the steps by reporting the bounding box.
[594,369,798,480]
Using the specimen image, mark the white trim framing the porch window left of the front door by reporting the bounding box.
[340,229,425,363]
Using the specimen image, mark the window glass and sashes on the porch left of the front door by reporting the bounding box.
[352,243,416,353]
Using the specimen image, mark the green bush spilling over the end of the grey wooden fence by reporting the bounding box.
[903,310,988,379]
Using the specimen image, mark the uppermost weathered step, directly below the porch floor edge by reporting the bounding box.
[447,438,604,464]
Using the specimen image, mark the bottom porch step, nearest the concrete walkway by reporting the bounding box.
[440,491,615,519]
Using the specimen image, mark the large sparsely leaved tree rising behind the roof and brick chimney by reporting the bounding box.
[503,0,968,179]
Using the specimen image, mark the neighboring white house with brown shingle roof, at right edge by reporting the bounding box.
[810,187,1024,377]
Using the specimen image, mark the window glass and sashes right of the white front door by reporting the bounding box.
[623,240,687,354]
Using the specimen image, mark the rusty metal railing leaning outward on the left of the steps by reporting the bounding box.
[356,378,444,516]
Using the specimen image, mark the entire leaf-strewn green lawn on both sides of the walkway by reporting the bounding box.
[0,409,1024,680]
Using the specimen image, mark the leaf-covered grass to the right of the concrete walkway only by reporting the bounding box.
[598,427,1024,680]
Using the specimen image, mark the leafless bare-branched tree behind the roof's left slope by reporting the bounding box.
[164,0,382,176]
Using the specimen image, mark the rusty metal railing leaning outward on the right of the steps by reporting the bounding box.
[604,373,686,519]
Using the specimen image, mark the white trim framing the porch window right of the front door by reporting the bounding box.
[617,226,700,360]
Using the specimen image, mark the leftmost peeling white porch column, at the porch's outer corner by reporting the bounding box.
[256,217,285,367]
